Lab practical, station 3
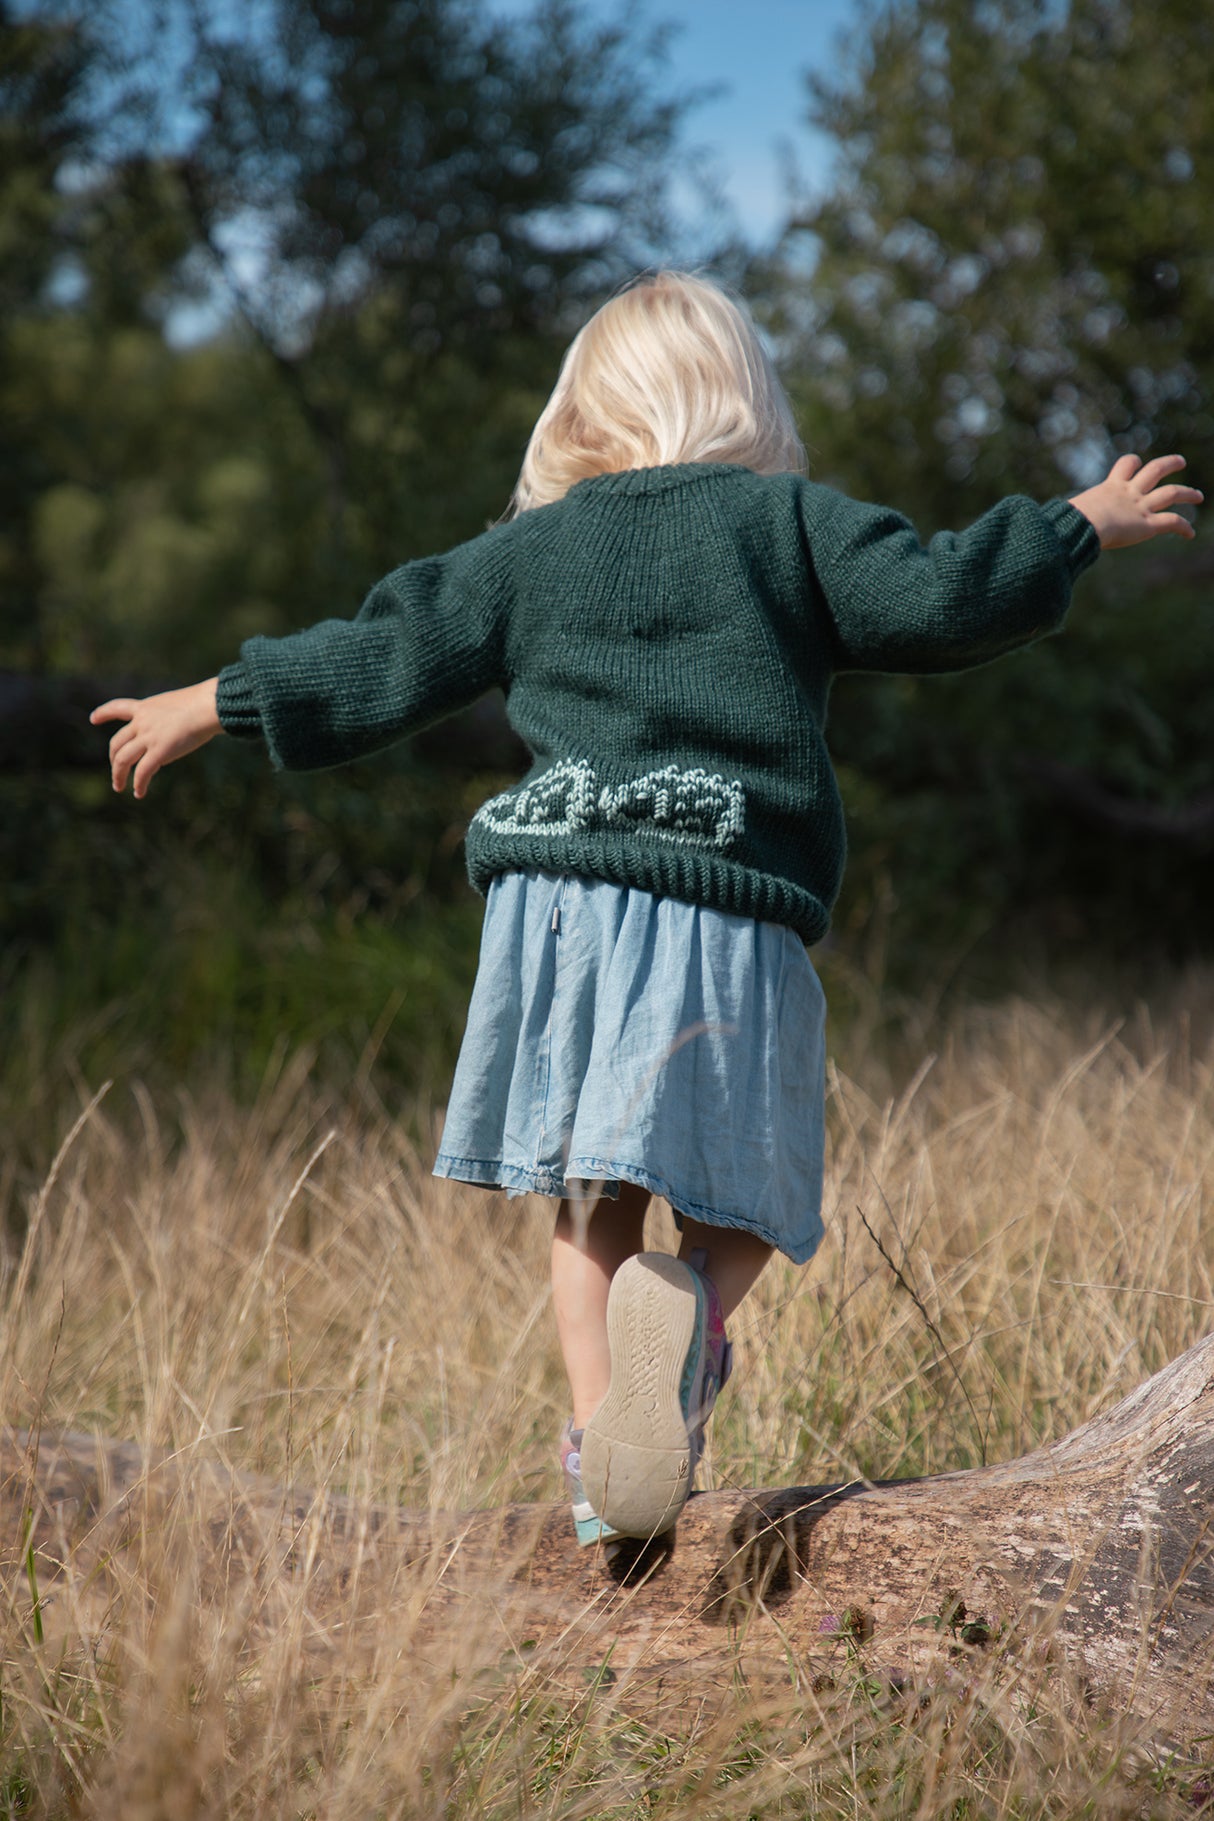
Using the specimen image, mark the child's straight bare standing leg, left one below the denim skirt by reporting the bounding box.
[551,1182,650,1429]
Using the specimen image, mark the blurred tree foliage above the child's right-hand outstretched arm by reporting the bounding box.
[775,0,1214,521]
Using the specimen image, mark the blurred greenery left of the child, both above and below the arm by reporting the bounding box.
[0,0,702,1073]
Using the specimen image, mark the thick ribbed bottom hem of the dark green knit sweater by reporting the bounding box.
[466,821,830,943]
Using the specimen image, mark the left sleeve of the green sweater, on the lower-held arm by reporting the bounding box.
[217,526,510,770]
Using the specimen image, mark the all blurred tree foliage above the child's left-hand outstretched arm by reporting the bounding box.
[0,0,691,672]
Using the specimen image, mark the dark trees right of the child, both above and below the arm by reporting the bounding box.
[764,0,1214,968]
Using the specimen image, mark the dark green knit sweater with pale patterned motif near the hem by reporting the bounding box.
[218,464,1099,941]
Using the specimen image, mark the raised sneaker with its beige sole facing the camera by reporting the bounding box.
[581,1251,732,1537]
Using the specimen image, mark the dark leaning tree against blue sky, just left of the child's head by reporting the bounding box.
[83,0,702,593]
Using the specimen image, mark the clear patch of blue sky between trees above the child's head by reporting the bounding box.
[490,0,855,242]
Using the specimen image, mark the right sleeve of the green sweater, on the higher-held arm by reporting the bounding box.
[801,483,1099,672]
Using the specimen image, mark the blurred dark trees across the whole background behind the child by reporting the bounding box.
[0,0,1214,1165]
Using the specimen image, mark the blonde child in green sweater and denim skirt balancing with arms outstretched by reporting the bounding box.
[93,271,1201,1542]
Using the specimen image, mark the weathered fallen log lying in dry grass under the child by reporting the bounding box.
[0,1337,1214,1741]
